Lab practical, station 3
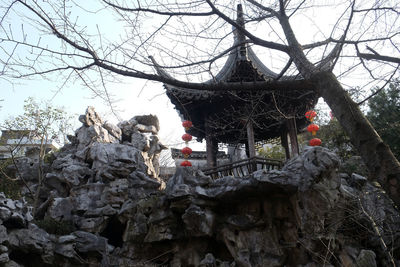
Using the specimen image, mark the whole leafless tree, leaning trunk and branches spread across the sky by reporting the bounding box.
[0,0,400,204]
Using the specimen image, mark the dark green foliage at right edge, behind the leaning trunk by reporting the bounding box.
[367,80,400,160]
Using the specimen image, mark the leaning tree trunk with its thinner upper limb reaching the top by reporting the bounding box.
[279,5,400,206]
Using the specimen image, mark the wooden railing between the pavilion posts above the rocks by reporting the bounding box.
[202,157,283,179]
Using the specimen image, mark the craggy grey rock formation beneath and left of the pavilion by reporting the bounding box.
[0,108,400,267]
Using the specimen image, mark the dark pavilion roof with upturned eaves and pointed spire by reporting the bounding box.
[151,5,319,144]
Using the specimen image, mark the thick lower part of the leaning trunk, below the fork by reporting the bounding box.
[311,72,400,206]
